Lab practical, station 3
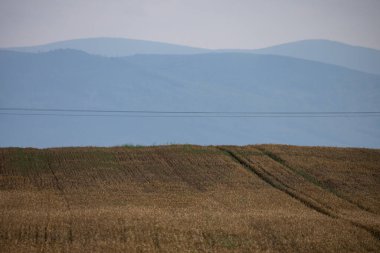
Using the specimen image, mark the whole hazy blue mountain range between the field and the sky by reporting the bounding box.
[0,39,380,147]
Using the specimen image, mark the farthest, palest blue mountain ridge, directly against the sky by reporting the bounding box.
[2,38,380,75]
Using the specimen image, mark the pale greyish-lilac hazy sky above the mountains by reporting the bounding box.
[0,0,380,49]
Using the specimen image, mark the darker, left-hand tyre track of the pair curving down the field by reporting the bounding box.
[218,147,380,241]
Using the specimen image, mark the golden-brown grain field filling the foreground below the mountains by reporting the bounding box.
[0,145,380,252]
